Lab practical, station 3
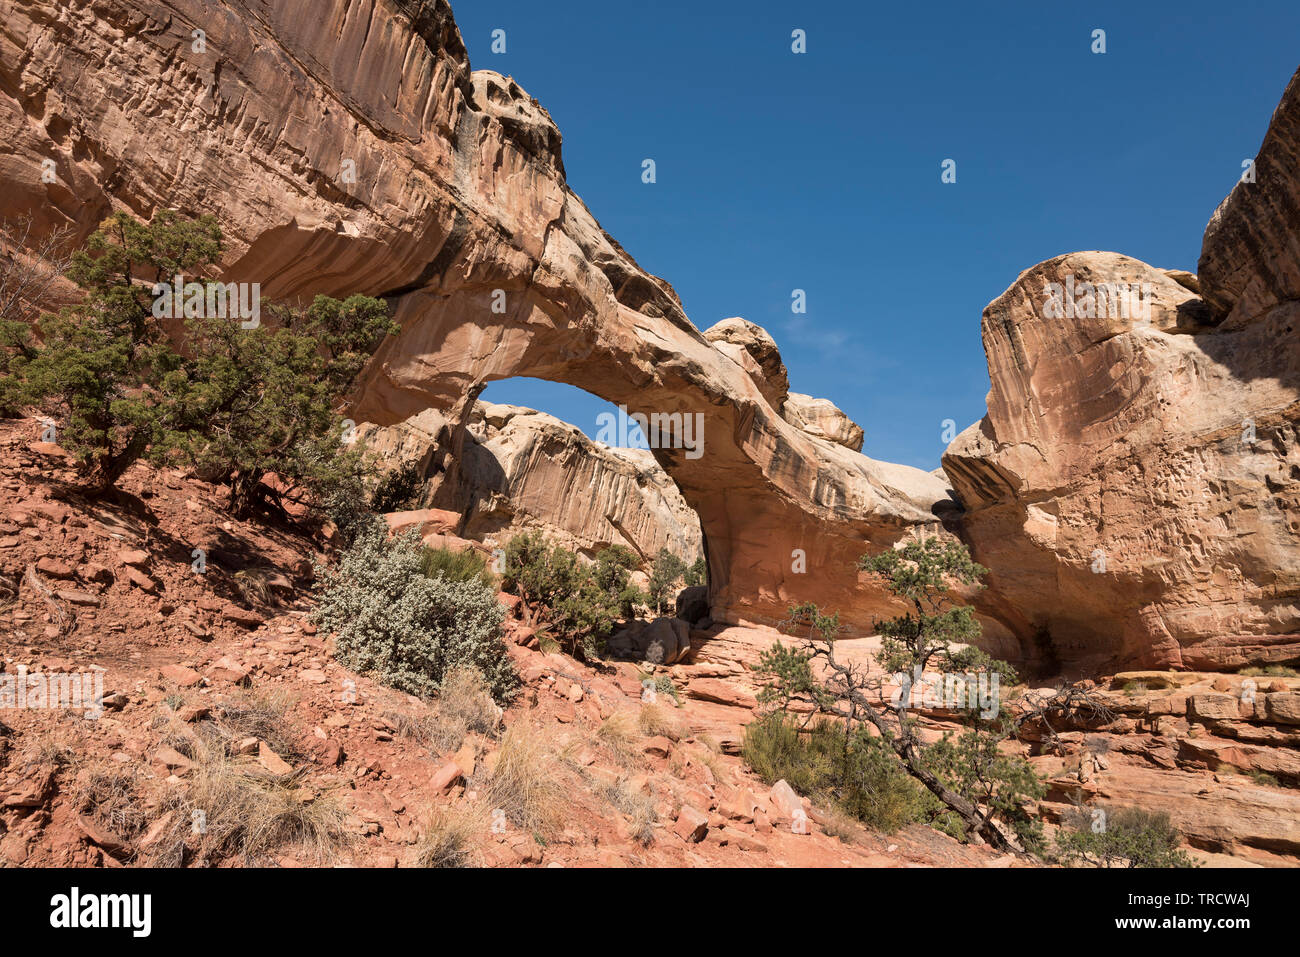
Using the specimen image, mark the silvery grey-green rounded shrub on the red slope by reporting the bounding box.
[312,520,519,702]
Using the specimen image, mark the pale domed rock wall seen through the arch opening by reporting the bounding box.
[363,402,703,564]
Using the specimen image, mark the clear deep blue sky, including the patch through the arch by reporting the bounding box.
[452,0,1300,468]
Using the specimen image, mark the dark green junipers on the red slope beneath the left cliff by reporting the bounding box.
[0,209,397,515]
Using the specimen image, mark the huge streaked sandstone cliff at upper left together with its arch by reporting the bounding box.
[0,0,952,627]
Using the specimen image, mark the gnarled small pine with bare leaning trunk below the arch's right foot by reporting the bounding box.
[746,538,1044,853]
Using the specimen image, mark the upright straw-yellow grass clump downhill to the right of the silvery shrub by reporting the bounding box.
[481,720,568,836]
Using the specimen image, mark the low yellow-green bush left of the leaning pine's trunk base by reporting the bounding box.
[741,711,939,833]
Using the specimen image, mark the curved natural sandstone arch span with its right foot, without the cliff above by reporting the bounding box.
[354,263,956,635]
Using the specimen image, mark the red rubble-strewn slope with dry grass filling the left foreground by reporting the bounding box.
[0,420,1011,867]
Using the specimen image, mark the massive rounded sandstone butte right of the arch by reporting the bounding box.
[944,243,1300,670]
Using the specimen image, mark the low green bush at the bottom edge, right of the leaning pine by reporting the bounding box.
[1054,807,1197,867]
